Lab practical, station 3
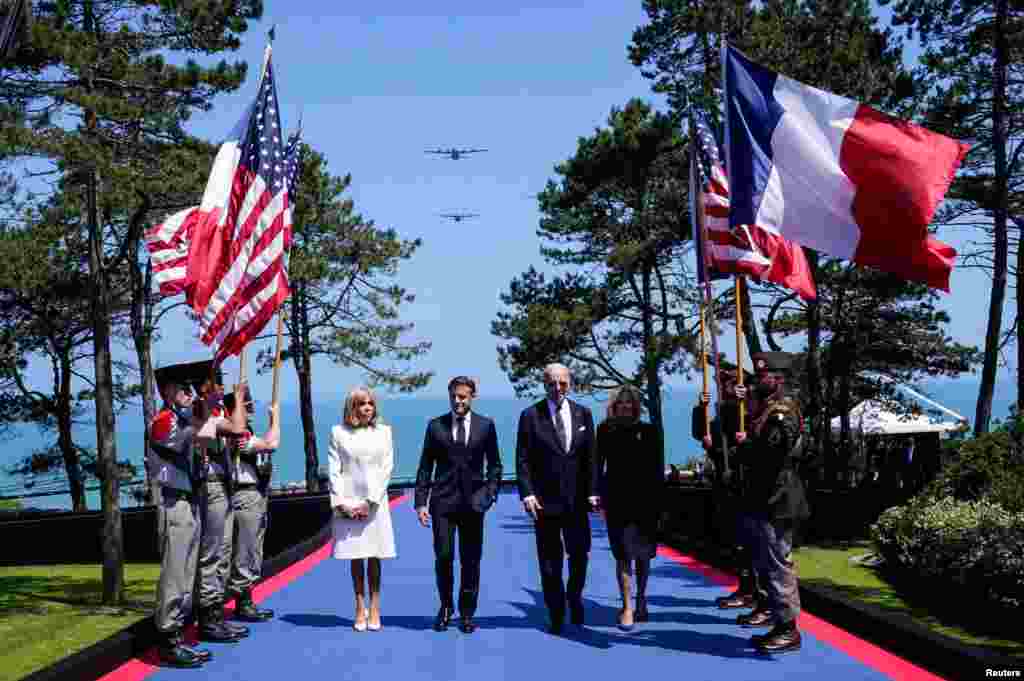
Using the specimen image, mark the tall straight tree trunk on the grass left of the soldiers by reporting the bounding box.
[87,169,124,605]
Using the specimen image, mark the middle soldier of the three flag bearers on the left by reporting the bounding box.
[197,372,249,643]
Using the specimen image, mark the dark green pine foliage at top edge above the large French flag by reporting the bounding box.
[629,0,914,115]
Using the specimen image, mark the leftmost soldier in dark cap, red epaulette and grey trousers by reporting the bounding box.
[147,363,245,668]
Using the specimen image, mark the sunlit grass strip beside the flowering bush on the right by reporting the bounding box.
[796,542,1024,659]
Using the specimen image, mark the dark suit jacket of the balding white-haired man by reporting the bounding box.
[515,399,597,515]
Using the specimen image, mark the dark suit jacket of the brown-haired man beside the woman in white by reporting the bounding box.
[416,412,502,513]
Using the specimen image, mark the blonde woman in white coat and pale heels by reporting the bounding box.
[328,387,395,632]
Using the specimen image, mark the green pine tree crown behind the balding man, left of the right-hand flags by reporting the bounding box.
[492,99,697,422]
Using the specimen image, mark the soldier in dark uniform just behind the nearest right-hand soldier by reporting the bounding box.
[692,360,762,610]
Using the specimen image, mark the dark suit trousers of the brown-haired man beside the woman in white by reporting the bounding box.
[432,508,483,616]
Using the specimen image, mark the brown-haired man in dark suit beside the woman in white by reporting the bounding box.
[416,376,502,634]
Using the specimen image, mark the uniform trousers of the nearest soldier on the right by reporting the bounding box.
[751,513,800,625]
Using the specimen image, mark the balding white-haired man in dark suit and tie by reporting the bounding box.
[515,365,598,634]
